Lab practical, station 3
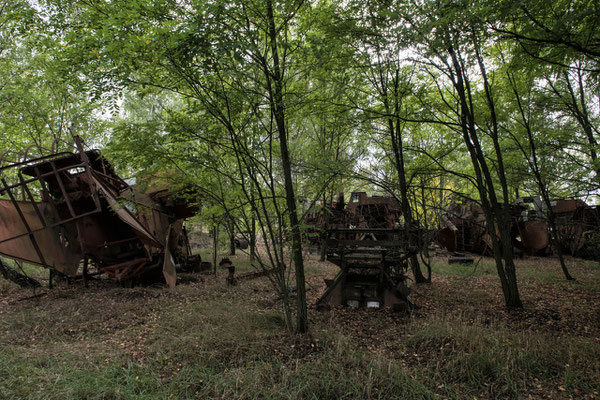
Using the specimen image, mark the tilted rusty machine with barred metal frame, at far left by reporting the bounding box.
[0,137,200,287]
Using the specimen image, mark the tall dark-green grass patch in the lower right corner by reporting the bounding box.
[406,319,600,398]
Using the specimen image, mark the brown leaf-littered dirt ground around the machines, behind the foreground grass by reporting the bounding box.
[0,256,600,398]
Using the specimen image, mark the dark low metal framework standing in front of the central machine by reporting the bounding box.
[317,228,418,310]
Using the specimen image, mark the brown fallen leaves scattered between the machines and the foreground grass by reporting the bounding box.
[0,255,600,399]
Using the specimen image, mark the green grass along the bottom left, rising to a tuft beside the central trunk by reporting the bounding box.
[0,294,433,399]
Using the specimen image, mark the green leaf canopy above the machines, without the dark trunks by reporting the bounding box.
[0,0,598,206]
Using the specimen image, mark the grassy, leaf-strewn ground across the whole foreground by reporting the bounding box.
[0,256,600,400]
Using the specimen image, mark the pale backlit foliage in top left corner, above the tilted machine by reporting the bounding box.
[0,0,106,161]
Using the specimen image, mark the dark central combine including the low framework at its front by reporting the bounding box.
[315,192,419,309]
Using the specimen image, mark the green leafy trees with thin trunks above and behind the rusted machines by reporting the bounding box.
[0,0,600,332]
